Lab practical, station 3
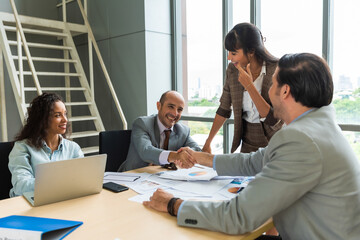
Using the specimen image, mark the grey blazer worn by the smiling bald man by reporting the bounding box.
[118,114,201,172]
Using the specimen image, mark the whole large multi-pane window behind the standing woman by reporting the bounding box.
[174,0,360,159]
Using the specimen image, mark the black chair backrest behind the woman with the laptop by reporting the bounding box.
[0,142,14,200]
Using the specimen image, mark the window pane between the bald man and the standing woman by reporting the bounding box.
[179,0,223,152]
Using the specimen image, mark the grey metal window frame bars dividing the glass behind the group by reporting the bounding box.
[170,0,360,153]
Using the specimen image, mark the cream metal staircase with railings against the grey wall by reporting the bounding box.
[0,0,127,146]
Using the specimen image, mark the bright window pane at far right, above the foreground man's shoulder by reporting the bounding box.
[333,0,360,124]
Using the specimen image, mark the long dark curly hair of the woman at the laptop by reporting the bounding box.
[15,93,69,148]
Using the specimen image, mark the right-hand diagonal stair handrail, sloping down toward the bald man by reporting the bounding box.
[75,0,127,130]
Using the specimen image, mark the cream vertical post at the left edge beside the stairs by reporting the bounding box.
[0,48,8,142]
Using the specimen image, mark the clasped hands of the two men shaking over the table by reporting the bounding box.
[168,147,214,168]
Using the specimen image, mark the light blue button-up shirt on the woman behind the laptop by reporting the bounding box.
[9,137,84,197]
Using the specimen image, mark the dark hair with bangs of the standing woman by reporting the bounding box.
[225,23,278,64]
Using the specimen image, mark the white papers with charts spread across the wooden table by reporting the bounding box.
[104,164,253,202]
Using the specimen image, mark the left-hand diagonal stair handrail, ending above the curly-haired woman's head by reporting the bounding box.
[10,0,42,95]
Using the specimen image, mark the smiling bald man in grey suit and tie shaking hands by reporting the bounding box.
[119,91,201,171]
